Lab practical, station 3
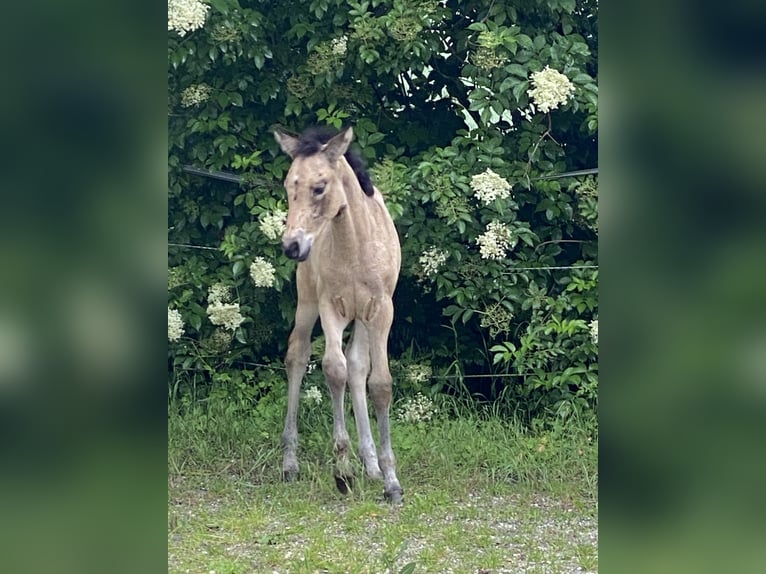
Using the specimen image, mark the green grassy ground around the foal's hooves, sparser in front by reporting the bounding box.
[168,401,598,574]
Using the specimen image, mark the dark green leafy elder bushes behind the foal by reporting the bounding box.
[168,0,598,424]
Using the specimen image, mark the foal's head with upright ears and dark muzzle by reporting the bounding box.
[274,127,354,261]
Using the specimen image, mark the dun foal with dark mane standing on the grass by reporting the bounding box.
[274,128,402,503]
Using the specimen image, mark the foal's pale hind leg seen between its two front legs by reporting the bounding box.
[346,321,383,480]
